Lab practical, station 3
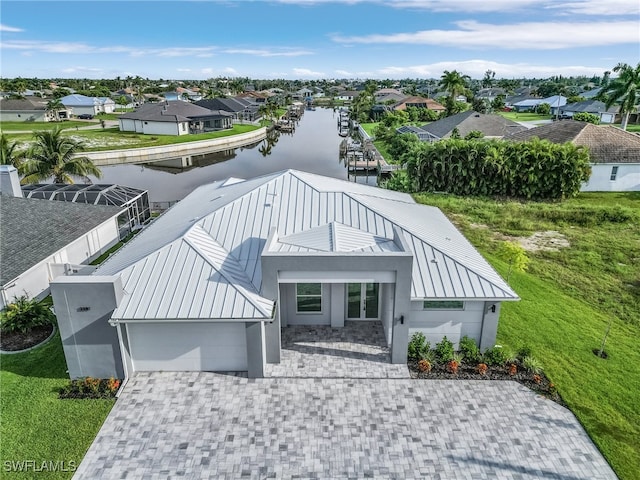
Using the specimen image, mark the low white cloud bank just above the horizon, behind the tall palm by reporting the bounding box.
[375,59,610,78]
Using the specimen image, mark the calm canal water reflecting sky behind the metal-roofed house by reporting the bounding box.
[92,108,376,203]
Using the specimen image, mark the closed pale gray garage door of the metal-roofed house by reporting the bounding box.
[127,323,247,372]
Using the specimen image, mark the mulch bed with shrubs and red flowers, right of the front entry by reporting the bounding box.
[407,361,566,407]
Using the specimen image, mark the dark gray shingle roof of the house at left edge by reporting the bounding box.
[0,195,123,285]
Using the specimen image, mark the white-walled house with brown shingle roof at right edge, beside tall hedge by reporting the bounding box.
[508,120,640,192]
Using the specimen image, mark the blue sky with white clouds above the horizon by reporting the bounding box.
[0,0,640,79]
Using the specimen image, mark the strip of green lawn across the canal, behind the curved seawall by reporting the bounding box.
[9,125,260,152]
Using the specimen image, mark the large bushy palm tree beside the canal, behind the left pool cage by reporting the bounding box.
[22,128,102,183]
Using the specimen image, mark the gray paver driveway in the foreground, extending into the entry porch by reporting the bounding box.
[74,322,616,480]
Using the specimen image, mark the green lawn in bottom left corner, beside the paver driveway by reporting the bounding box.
[0,334,114,479]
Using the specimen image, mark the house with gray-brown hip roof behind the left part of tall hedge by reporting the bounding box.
[398,110,527,141]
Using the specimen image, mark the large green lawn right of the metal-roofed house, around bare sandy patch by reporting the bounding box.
[416,193,640,480]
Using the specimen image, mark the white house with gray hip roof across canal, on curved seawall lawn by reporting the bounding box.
[118,100,233,135]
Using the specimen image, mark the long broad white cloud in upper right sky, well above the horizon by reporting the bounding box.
[332,20,638,50]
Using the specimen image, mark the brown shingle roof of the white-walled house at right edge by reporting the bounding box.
[508,120,640,163]
